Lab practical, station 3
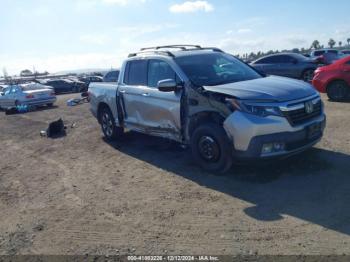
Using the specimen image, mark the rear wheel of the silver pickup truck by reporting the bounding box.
[99,107,124,141]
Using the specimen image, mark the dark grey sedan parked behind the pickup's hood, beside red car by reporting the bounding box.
[250,53,318,82]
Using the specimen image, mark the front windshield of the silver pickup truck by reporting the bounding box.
[175,53,262,86]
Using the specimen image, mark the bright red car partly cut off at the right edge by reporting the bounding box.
[312,56,350,101]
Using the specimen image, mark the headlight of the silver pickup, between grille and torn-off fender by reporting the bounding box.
[226,98,282,117]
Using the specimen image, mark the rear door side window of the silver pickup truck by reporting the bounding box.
[125,60,148,86]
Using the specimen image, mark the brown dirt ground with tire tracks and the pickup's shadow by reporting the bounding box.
[0,95,350,255]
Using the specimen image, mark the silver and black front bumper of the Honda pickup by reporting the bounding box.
[224,112,326,159]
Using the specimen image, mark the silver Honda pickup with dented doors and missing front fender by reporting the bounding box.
[89,45,326,172]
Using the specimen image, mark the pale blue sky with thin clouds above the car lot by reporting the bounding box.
[0,0,350,75]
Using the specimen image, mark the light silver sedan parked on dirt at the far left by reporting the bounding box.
[0,85,56,109]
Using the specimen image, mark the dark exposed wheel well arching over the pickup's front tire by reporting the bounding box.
[187,111,225,138]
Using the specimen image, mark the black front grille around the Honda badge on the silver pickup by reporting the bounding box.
[284,100,322,126]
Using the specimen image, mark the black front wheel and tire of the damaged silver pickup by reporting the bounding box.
[191,123,233,174]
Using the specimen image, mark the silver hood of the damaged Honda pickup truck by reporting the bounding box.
[203,76,317,102]
